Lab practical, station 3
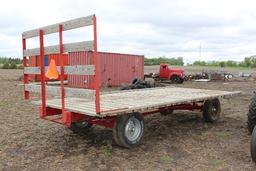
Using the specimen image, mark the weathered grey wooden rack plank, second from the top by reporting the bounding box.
[23,41,94,56]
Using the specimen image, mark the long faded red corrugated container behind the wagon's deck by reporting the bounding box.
[68,52,144,88]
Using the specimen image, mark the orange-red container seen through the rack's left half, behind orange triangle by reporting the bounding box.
[29,54,68,81]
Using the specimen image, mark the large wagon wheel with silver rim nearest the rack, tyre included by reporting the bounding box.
[113,113,144,148]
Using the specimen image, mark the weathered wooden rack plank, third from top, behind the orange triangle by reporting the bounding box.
[24,65,95,75]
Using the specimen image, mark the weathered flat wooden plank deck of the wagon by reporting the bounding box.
[34,87,240,117]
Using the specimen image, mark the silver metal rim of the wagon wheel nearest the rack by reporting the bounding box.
[125,117,141,141]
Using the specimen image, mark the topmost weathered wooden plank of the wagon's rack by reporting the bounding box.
[22,15,94,39]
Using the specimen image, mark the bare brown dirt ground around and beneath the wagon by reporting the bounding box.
[0,67,256,171]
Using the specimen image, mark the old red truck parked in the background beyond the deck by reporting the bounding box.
[145,64,184,84]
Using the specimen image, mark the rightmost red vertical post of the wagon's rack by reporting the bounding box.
[93,15,100,114]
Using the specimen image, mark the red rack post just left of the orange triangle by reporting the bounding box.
[39,30,46,117]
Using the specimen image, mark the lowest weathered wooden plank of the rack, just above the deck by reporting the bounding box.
[25,84,95,100]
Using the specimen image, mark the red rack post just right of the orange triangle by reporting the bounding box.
[59,24,65,113]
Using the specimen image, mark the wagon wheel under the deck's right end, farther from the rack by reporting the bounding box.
[203,99,221,122]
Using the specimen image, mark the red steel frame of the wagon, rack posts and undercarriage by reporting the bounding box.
[22,15,203,128]
